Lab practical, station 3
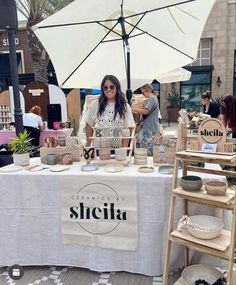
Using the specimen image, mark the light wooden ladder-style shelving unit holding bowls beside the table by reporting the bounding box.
[163,123,236,285]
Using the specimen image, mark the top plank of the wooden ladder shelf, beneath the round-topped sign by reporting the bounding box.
[176,150,236,165]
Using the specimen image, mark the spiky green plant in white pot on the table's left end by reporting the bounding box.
[10,130,33,166]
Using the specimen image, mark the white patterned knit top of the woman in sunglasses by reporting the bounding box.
[85,100,135,127]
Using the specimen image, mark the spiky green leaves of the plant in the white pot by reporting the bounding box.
[10,130,33,154]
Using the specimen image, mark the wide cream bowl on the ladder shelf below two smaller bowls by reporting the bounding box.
[187,215,224,239]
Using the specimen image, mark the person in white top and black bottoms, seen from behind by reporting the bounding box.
[23,105,43,147]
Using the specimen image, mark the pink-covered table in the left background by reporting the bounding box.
[0,128,73,145]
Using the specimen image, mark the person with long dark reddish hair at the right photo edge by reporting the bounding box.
[221,95,236,138]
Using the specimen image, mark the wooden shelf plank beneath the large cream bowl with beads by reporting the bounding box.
[170,230,231,255]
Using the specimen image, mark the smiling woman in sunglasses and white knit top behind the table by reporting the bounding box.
[85,75,135,146]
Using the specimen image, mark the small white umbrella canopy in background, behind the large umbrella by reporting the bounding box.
[156,67,192,83]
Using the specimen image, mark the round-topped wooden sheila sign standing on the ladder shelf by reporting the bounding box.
[198,118,226,152]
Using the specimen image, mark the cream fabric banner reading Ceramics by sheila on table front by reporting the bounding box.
[59,175,138,250]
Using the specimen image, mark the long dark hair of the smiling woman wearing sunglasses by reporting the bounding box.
[98,75,127,120]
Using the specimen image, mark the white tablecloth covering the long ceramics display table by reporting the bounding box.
[0,159,230,275]
